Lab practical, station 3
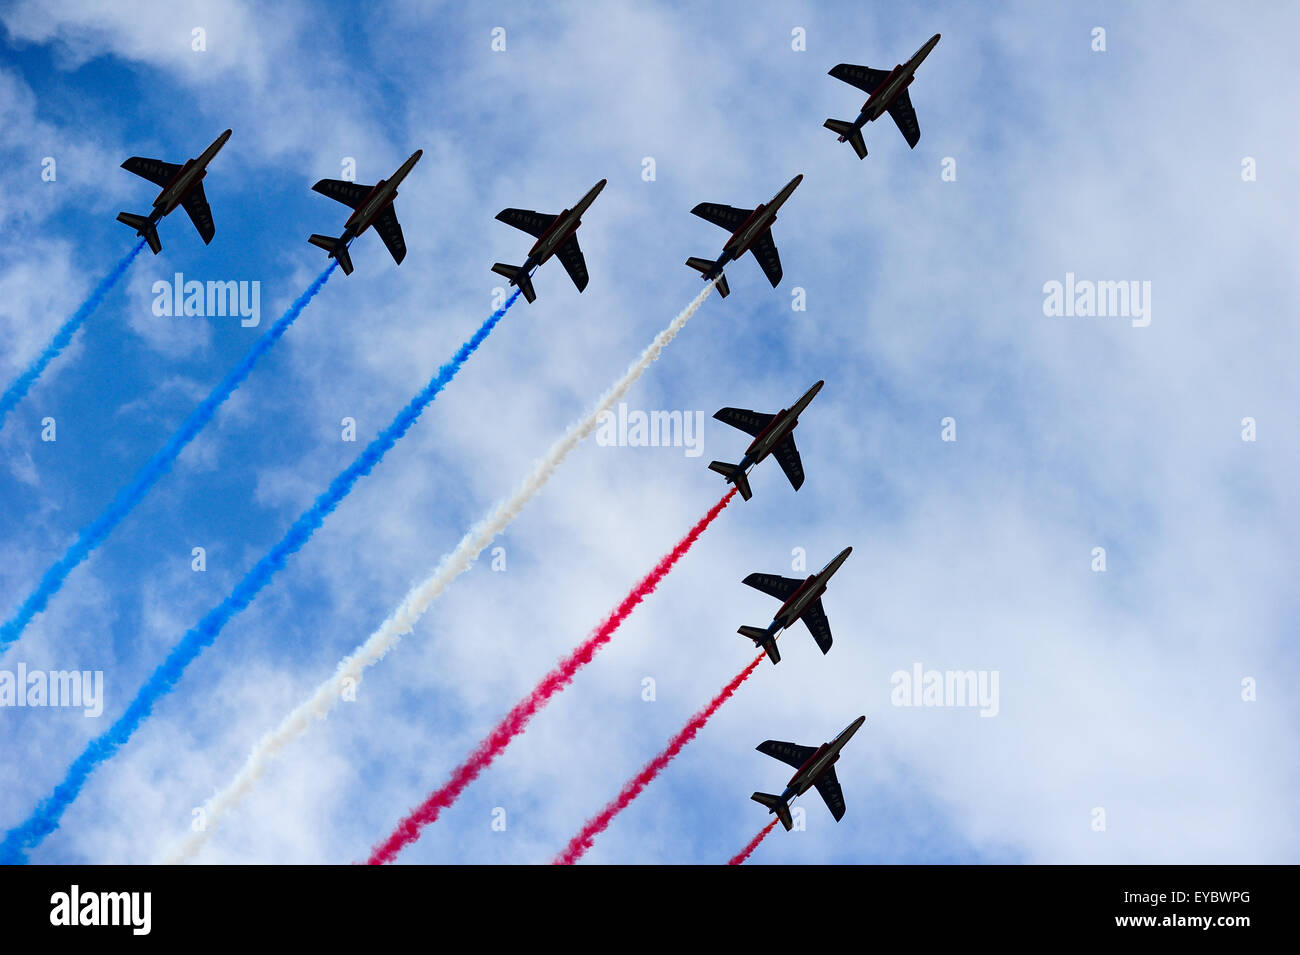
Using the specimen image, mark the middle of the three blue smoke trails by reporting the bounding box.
[0,260,338,654]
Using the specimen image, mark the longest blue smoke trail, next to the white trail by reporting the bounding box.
[0,287,519,865]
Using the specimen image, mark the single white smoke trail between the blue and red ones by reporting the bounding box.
[160,282,715,865]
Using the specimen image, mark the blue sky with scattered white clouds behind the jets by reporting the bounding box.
[0,3,1300,863]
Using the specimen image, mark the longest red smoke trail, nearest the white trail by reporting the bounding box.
[365,487,736,865]
